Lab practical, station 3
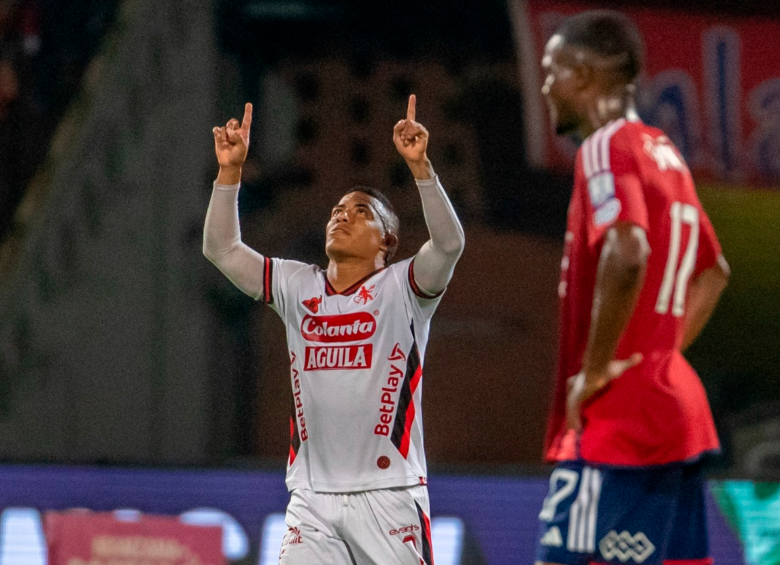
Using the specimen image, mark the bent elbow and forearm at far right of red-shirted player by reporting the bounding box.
[680,255,731,351]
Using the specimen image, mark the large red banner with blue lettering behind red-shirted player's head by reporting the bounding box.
[510,0,780,183]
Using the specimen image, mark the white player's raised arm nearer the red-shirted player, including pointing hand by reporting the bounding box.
[393,94,465,295]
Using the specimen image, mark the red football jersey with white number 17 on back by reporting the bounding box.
[546,119,721,466]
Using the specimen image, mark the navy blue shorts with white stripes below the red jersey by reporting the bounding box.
[536,461,712,565]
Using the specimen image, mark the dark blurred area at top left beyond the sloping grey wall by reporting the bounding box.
[0,0,118,241]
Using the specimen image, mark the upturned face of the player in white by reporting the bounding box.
[325,192,385,260]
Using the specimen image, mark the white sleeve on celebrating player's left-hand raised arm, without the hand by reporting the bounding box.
[203,182,267,300]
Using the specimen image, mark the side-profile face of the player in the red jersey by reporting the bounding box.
[542,34,579,135]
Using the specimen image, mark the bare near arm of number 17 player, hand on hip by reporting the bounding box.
[566,222,650,431]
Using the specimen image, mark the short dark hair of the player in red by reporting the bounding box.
[556,10,644,83]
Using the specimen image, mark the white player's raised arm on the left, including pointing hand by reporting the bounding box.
[203,103,265,300]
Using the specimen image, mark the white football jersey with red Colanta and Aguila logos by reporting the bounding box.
[263,253,441,492]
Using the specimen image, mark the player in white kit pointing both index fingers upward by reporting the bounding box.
[203,95,464,565]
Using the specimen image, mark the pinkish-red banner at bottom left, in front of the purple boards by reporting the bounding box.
[44,511,225,565]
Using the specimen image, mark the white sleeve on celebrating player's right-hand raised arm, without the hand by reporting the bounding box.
[411,175,465,297]
